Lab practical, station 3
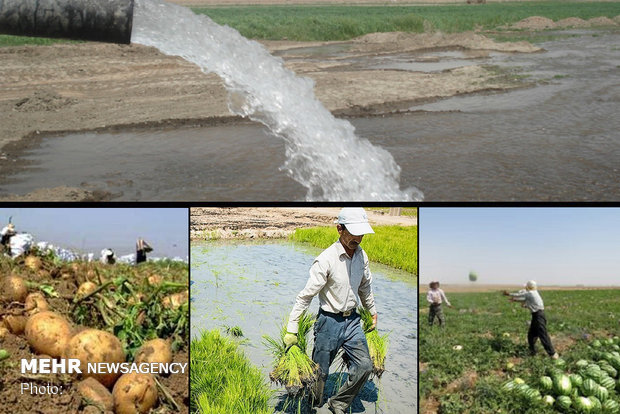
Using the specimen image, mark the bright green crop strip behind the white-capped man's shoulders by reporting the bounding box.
[292,226,418,275]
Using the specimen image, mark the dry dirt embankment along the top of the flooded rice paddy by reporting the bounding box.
[190,207,417,240]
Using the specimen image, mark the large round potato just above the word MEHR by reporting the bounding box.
[25,311,73,358]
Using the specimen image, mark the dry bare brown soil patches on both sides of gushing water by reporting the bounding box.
[0,27,540,201]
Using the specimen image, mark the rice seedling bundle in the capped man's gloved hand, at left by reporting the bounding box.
[263,312,319,397]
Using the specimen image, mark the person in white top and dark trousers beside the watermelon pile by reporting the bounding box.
[504,280,559,359]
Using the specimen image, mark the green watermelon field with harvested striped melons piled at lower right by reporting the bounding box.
[419,289,620,414]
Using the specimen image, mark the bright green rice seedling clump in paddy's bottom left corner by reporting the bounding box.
[190,329,273,414]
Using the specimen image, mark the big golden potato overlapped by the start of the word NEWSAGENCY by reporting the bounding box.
[65,328,125,388]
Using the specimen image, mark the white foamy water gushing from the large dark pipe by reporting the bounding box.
[131,0,423,201]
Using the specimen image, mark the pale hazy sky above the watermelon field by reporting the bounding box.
[419,207,620,286]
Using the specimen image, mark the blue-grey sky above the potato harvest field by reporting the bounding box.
[0,208,189,259]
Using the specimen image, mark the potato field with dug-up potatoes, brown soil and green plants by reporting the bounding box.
[0,249,189,414]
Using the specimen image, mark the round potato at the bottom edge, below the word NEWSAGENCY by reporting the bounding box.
[112,373,157,414]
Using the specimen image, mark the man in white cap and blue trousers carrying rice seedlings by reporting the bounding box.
[284,208,377,414]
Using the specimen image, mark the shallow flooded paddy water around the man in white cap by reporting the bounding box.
[191,241,418,414]
